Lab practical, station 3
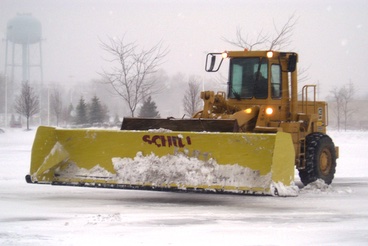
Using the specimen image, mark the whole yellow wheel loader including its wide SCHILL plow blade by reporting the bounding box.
[26,50,338,196]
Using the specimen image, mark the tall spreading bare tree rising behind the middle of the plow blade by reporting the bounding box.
[101,38,168,117]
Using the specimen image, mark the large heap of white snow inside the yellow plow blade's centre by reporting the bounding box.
[113,153,271,189]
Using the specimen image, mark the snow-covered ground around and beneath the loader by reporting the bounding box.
[0,129,368,245]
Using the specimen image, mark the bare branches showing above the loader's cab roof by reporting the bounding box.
[223,15,297,50]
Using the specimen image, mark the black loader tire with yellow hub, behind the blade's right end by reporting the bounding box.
[299,133,336,185]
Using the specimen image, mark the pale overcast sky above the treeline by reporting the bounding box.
[0,0,368,97]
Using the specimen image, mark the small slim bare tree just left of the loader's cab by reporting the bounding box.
[183,76,201,116]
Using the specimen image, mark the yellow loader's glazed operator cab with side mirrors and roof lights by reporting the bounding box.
[205,50,297,103]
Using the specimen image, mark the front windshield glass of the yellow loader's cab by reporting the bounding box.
[229,57,268,99]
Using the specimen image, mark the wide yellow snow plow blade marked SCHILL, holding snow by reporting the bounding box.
[26,126,296,196]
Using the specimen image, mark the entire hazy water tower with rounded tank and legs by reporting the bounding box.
[4,14,43,125]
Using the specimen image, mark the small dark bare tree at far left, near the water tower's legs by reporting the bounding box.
[15,81,40,130]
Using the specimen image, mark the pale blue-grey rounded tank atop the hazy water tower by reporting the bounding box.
[6,14,42,44]
